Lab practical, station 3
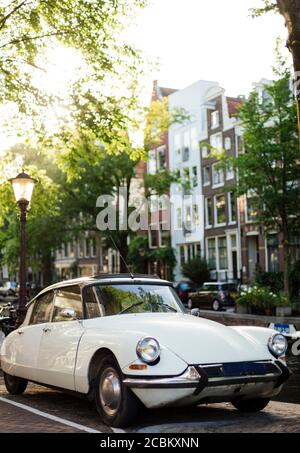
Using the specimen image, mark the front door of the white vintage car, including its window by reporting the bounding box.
[37,285,84,390]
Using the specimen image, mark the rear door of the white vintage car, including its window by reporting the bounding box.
[6,291,54,381]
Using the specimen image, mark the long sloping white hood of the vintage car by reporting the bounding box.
[85,313,271,364]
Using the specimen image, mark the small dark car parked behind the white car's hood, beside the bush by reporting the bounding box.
[187,282,238,311]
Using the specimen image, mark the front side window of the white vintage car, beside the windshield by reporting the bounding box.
[52,285,83,322]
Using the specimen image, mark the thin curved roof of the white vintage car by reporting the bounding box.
[27,274,172,306]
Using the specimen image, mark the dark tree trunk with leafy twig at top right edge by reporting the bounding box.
[253,0,300,140]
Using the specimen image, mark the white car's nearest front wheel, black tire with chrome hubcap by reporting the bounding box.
[94,355,141,428]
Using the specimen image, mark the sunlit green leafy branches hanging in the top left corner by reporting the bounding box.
[0,0,146,112]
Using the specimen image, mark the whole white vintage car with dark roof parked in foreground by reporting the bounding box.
[1,275,289,427]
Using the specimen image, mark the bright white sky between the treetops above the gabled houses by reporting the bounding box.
[123,0,286,96]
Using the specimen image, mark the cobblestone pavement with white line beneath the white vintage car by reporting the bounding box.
[0,375,300,434]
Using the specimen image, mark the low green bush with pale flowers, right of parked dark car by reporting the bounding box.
[236,286,289,309]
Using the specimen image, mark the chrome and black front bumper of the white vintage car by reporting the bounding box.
[123,360,290,395]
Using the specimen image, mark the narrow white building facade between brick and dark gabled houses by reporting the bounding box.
[169,80,218,281]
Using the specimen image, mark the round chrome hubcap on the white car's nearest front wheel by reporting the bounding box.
[99,368,121,416]
